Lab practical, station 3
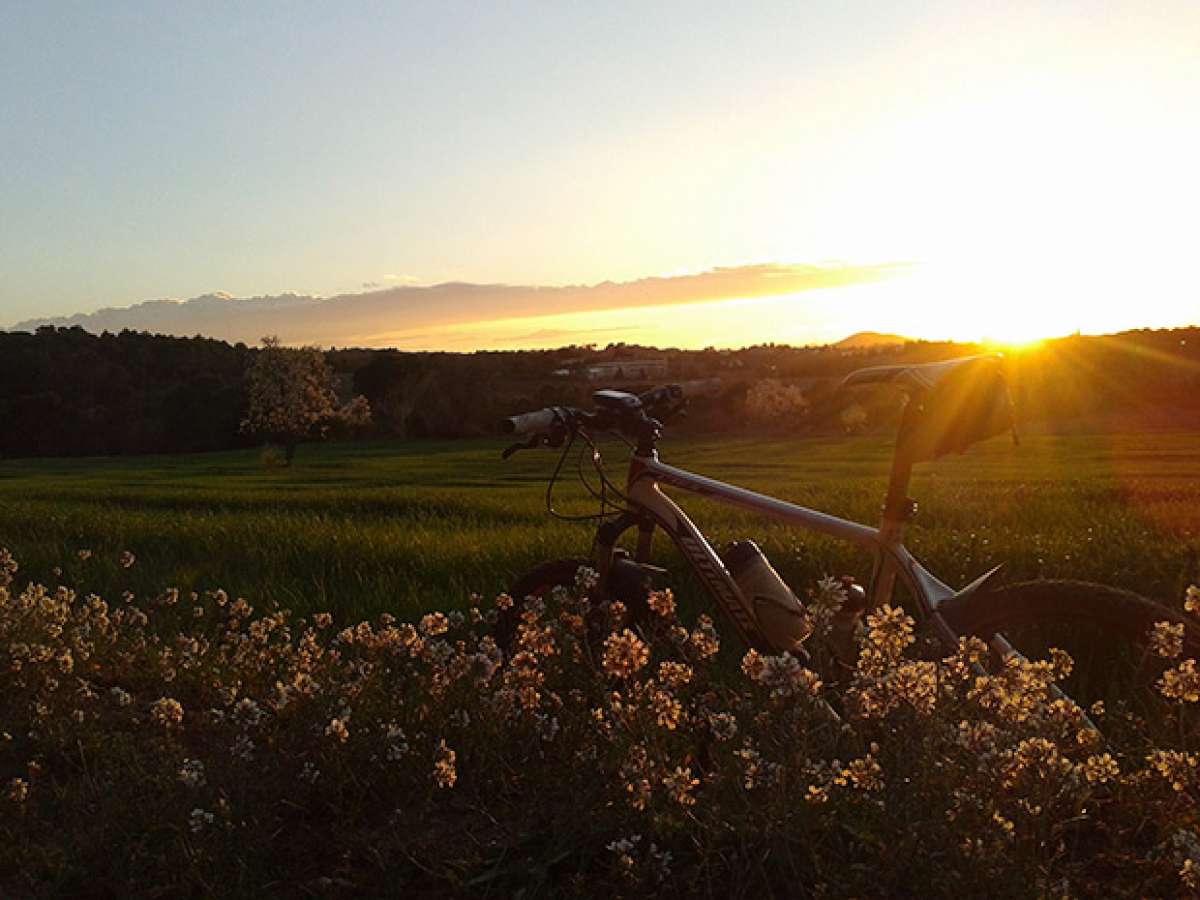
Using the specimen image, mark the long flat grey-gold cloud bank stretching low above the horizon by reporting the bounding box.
[4,263,907,349]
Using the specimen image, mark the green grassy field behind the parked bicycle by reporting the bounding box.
[0,433,1200,618]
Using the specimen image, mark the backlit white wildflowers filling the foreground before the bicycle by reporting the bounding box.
[0,552,1200,896]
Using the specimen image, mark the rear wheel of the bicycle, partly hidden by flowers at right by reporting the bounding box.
[940,581,1200,739]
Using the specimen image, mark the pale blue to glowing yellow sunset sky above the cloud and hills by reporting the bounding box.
[0,0,1200,347]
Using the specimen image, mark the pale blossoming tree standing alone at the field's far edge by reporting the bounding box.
[241,337,371,466]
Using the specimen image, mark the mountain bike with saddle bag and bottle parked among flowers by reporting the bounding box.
[502,356,1200,715]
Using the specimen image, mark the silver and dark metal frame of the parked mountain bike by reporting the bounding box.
[593,451,964,647]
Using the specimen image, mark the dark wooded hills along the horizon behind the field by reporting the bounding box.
[0,326,1200,456]
